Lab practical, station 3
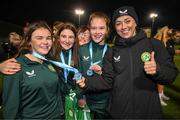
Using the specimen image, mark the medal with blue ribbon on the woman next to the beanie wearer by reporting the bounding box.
[86,42,107,76]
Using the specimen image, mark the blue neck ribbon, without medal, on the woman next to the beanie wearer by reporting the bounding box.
[89,42,107,66]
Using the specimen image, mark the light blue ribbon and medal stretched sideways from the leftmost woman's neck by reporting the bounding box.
[32,51,82,80]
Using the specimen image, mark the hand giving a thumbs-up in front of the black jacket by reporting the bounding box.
[144,51,157,75]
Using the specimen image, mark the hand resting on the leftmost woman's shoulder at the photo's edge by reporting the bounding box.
[0,58,21,75]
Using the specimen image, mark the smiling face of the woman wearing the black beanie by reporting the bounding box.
[115,15,137,38]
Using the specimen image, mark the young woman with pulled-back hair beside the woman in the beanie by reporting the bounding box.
[79,12,110,119]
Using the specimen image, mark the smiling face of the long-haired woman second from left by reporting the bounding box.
[59,29,75,50]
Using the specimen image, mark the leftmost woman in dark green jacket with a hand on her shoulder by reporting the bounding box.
[3,21,63,119]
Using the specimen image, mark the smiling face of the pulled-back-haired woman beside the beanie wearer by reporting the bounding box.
[90,17,108,44]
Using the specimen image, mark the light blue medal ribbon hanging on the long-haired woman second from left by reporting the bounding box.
[60,49,72,83]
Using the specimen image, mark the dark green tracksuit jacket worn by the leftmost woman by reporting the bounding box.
[3,56,63,119]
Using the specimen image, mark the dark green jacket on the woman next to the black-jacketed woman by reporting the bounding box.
[79,41,110,114]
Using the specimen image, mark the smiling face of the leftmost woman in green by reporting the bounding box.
[30,28,52,56]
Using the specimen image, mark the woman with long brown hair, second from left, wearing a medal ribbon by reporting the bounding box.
[56,23,79,90]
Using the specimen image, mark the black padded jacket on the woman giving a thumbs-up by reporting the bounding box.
[85,31,178,119]
